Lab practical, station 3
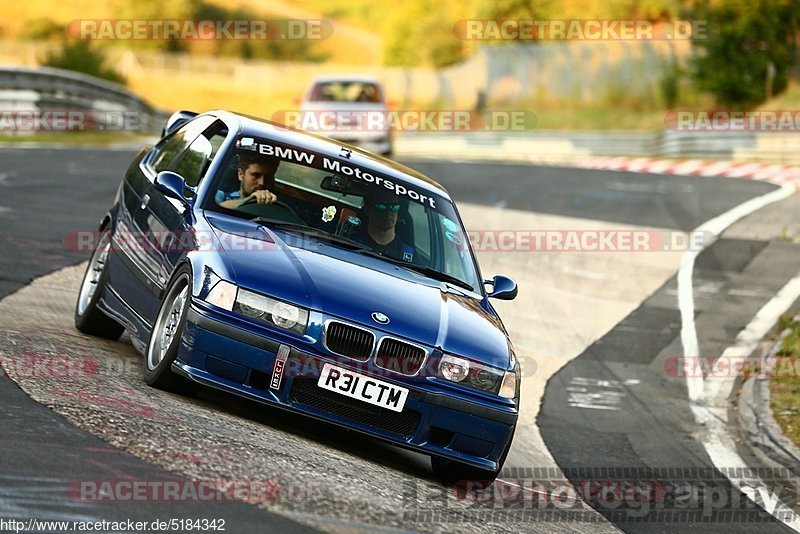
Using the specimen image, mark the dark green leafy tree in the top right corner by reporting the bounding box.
[692,0,800,108]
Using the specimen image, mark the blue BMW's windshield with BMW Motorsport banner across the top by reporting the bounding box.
[205,137,480,292]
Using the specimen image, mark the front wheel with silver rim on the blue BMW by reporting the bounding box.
[143,267,202,396]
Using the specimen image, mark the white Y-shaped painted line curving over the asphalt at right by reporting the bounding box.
[678,184,800,532]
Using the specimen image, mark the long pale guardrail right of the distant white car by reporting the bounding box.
[395,131,800,165]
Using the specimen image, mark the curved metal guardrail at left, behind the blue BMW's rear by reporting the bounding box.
[0,67,168,133]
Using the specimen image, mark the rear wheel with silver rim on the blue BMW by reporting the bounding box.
[75,232,125,339]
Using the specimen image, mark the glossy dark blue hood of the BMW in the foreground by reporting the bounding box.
[206,216,508,366]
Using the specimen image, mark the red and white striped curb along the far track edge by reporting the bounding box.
[575,156,800,187]
